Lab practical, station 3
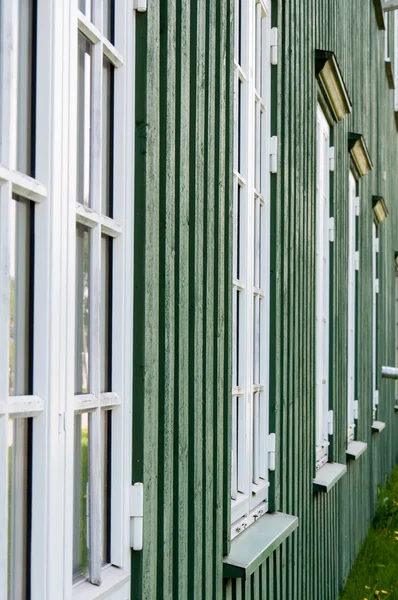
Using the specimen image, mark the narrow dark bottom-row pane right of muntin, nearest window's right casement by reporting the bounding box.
[101,410,112,565]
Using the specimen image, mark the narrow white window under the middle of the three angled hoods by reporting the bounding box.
[347,172,359,442]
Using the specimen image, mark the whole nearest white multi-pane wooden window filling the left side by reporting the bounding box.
[0,0,134,600]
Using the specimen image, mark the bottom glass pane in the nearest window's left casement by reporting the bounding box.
[8,419,30,600]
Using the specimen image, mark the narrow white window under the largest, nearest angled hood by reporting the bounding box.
[315,105,331,469]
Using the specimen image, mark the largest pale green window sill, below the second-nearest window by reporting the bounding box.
[223,512,298,579]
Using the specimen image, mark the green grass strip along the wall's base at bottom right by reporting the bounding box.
[340,466,398,600]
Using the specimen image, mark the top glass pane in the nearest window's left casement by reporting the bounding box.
[17,0,36,175]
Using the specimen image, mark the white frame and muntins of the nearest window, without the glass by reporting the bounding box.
[0,0,135,600]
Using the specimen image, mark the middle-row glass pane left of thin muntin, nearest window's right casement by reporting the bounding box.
[75,224,90,394]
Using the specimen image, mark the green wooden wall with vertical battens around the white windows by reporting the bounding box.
[131,0,398,600]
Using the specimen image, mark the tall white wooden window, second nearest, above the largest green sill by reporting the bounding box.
[231,0,271,537]
